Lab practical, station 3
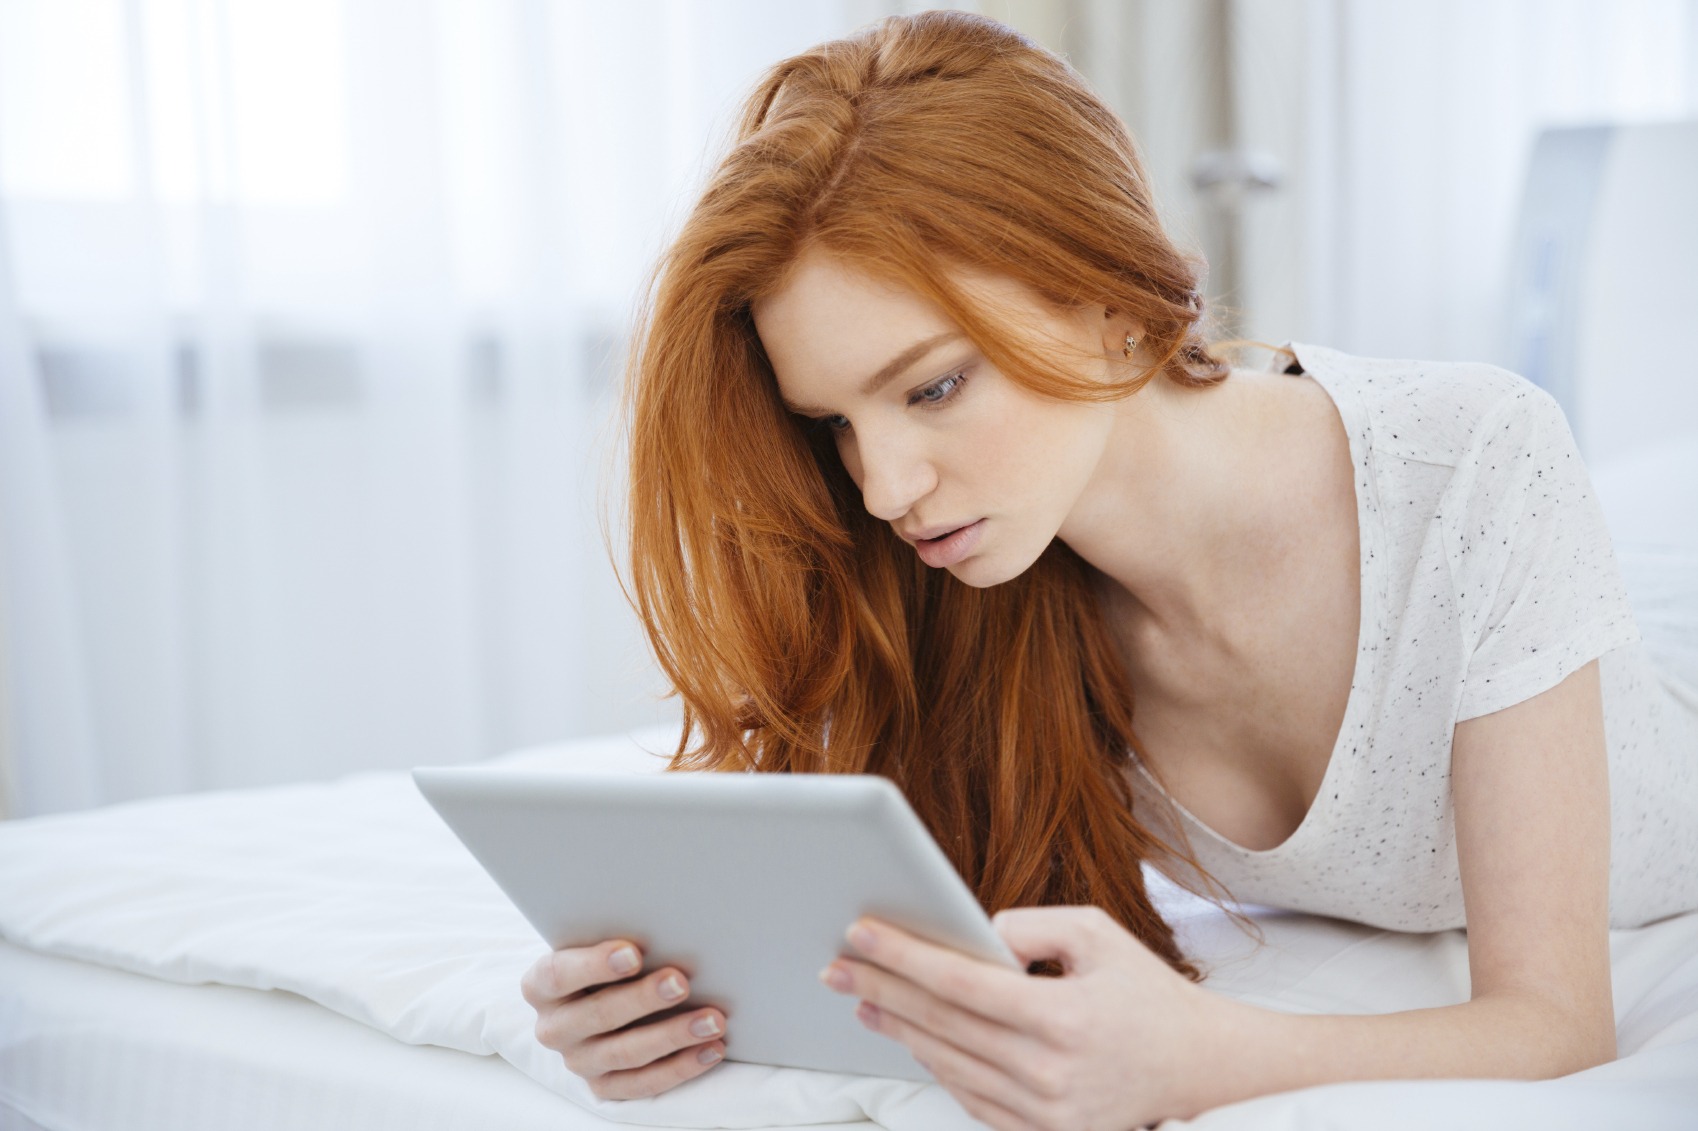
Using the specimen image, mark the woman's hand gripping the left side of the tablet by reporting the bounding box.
[520,939,725,1099]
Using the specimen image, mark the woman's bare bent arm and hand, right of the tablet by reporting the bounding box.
[827,662,1615,1131]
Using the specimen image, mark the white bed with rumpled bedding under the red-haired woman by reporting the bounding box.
[0,547,1698,1131]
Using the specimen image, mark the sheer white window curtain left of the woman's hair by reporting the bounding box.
[0,0,944,815]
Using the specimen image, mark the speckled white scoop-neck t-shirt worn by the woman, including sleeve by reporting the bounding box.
[1129,343,1698,931]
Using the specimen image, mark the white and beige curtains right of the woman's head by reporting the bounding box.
[1063,0,1698,365]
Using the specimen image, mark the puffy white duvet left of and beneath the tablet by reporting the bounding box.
[0,734,968,1131]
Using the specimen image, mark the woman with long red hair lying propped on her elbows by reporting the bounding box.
[525,12,1698,1128]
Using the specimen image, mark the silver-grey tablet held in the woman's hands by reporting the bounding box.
[413,766,1022,1080]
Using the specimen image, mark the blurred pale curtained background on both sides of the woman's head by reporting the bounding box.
[0,0,1698,815]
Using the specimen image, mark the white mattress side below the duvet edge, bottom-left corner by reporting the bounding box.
[0,943,874,1131]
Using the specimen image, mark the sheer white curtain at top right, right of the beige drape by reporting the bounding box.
[1276,0,1698,367]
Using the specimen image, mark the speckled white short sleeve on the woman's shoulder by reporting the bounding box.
[1445,379,1639,722]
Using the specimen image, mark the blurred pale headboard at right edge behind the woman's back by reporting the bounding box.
[1508,121,1698,545]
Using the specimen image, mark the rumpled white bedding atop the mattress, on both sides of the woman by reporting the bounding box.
[0,732,1698,1131]
